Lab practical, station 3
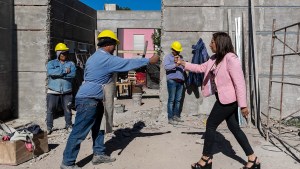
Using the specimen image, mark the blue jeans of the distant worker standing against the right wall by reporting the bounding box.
[167,79,183,120]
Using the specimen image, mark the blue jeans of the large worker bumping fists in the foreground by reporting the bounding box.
[63,98,104,166]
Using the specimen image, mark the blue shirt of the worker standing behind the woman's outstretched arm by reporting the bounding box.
[164,53,184,80]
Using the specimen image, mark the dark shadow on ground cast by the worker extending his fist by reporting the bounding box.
[77,121,171,167]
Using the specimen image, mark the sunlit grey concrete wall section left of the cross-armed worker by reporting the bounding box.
[14,0,48,118]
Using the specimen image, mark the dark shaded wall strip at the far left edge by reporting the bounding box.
[0,0,13,120]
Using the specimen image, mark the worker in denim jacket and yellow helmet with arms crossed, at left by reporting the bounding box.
[46,43,76,134]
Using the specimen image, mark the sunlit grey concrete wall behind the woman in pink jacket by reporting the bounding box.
[160,0,300,119]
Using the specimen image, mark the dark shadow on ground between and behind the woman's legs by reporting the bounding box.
[181,132,246,165]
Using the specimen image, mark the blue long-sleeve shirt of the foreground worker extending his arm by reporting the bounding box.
[76,49,149,99]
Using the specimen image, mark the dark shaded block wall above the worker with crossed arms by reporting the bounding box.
[49,0,97,55]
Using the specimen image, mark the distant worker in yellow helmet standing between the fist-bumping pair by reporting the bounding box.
[164,41,184,125]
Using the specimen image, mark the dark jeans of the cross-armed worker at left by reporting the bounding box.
[46,93,72,129]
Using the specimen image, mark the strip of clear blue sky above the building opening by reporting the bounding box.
[80,0,161,10]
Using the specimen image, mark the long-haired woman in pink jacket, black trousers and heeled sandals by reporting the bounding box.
[177,32,260,169]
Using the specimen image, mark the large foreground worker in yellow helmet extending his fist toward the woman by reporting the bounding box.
[60,30,159,169]
